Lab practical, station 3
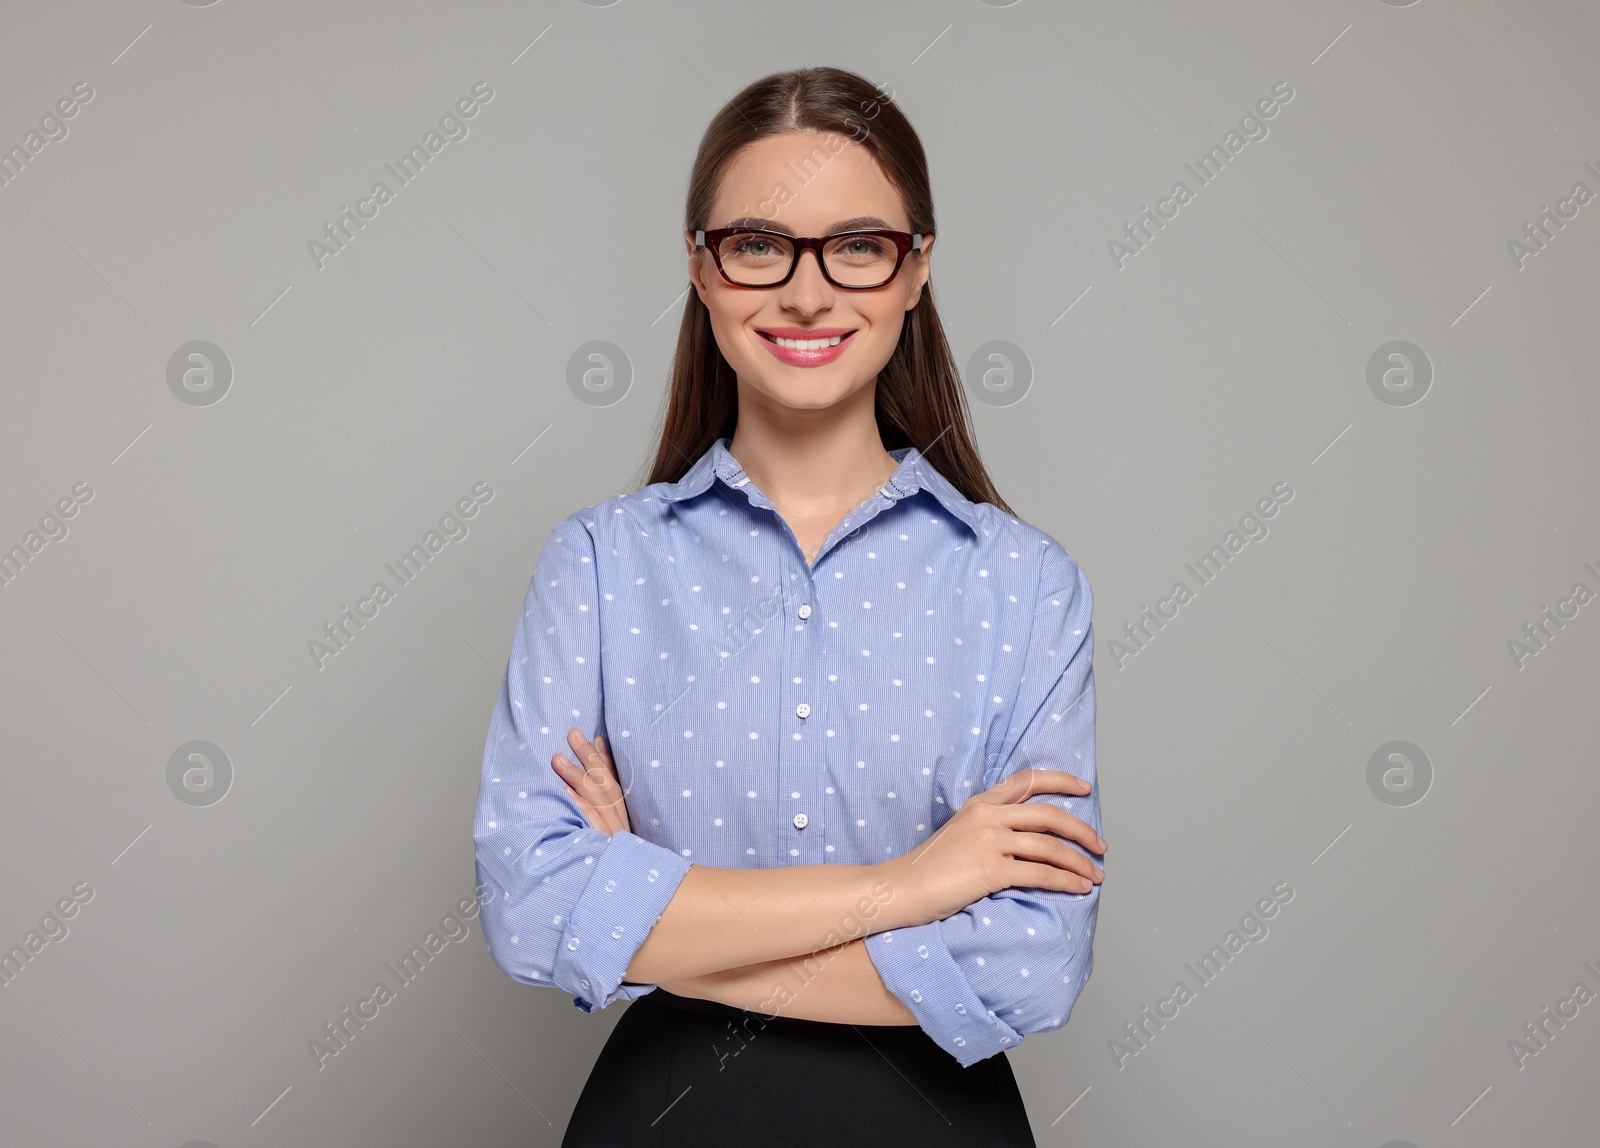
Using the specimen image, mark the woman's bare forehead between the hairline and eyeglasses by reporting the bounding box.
[710,131,910,235]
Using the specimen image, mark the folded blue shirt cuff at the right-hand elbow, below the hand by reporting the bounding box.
[867,921,1022,1066]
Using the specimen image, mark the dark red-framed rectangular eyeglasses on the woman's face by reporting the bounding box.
[694,227,931,291]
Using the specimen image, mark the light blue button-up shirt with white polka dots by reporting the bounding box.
[472,438,1101,1065]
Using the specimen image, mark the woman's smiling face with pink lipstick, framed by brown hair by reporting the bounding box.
[685,131,933,411]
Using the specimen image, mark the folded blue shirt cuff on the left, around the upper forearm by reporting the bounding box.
[550,830,690,1012]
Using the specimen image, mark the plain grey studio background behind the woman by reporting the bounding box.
[0,0,1600,1148]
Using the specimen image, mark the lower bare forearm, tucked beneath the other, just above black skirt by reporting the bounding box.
[661,937,917,1025]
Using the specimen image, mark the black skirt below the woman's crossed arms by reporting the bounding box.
[562,988,1035,1148]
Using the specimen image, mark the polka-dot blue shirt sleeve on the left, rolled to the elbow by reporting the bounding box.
[472,515,690,1012]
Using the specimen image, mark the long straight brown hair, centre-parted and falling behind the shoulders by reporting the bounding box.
[636,67,1014,513]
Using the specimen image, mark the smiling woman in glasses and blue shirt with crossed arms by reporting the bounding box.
[474,67,1106,1148]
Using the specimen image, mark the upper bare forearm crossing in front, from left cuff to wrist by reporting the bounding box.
[624,862,922,985]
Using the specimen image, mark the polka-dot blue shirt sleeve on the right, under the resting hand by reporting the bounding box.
[867,540,1101,1065]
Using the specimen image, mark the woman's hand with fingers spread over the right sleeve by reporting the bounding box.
[882,769,1106,921]
